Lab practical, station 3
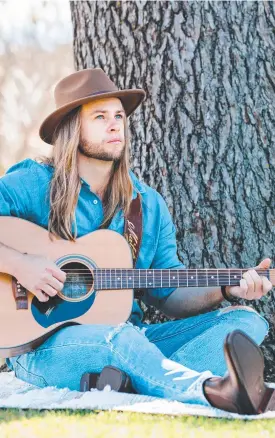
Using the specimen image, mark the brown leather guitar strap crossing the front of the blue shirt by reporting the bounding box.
[124,193,144,298]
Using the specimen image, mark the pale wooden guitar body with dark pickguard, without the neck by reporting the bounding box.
[0,216,133,358]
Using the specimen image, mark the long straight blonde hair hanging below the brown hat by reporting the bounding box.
[38,107,133,241]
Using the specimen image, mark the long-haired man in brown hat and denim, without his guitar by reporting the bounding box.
[0,69,273,413]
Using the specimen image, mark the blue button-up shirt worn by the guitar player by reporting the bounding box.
[0,158,184,325]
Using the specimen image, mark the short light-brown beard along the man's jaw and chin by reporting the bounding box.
[78,138,125,162]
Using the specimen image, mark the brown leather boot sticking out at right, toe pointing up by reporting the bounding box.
[204,330,275,415]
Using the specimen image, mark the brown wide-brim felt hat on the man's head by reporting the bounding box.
[39,68,146,144]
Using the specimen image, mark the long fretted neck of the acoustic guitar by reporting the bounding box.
[94,269,275,290]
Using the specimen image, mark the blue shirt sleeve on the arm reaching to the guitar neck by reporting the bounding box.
[144,194,185,304]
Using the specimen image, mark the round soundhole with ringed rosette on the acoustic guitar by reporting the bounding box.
[55,255,96,302]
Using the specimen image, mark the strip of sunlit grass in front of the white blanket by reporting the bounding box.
[0,409,275,438]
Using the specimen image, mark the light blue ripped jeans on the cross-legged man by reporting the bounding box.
[6,306,268,406]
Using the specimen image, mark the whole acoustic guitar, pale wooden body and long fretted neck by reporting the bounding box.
[0,216,275,358]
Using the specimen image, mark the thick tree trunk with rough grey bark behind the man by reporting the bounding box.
[71,1,275,378]
